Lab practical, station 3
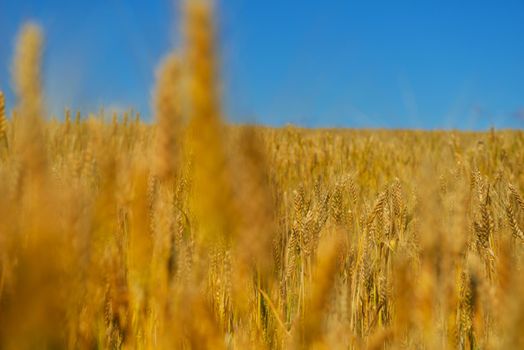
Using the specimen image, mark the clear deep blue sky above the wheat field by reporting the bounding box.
[0,0,524,129]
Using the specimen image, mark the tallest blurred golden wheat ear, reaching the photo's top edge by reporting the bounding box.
[184,0,232,245]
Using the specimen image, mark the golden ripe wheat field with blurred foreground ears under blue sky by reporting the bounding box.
[0,1,524,349]
